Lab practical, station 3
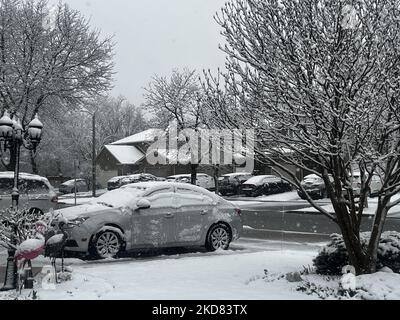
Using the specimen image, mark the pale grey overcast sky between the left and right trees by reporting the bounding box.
[50,0,225,105]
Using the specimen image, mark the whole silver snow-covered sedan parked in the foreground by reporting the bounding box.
[52,182,243,258]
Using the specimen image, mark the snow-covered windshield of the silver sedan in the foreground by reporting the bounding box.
[92,186,146,208]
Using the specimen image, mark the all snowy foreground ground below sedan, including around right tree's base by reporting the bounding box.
[0,239,400,300]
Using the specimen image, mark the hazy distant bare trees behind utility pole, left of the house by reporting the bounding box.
[32,96,149,180]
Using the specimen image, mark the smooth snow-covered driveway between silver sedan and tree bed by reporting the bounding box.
[34,250,316,300]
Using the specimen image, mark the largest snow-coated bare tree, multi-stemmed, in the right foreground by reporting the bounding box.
[205,0,400,274]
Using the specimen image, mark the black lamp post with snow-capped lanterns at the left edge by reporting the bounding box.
[0,110,43,291]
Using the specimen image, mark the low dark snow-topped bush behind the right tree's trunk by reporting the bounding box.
[313,231,400,275]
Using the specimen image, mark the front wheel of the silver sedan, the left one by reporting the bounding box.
[89,230,122,259]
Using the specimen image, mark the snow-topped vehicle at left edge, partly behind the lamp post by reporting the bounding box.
[0,171,58,214]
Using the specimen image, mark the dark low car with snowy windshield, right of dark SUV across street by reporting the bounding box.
[242,175,292,197]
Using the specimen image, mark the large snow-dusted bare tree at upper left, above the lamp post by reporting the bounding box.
[0,0,113,170]
